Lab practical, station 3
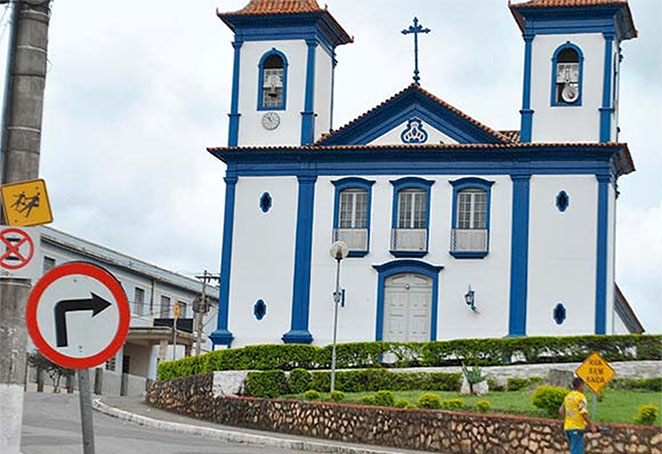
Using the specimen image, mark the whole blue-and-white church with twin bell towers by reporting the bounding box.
[209,0,636,346]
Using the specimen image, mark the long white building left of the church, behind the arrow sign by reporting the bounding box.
[40,227,218,383]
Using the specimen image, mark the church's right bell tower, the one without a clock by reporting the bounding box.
[509,0,637,143]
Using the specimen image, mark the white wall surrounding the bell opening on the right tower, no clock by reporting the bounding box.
[531,33,605,142]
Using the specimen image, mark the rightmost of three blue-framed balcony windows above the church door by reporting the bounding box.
[450,177,494,258]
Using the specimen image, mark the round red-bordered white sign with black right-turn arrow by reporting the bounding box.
[25,262,131,369]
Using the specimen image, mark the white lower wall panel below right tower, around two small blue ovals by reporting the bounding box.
[526,175,598,336]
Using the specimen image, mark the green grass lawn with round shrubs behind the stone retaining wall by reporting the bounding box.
[284,389,662,425]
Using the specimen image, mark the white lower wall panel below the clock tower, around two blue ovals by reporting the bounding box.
[228,177,298,347]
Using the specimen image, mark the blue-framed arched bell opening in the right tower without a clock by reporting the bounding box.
[552,42,584,106]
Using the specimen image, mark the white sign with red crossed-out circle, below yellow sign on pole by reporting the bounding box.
[0,225,40,279]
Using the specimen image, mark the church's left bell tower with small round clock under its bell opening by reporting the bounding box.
[217,0,352,147]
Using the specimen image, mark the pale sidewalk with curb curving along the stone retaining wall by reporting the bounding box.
[92,397,436,454]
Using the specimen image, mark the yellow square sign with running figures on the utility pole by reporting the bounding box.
[0,179,53,226]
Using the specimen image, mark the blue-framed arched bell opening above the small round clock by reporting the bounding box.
[257,48,287,110]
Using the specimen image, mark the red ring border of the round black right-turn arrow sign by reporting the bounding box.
[25,262,131,369]
